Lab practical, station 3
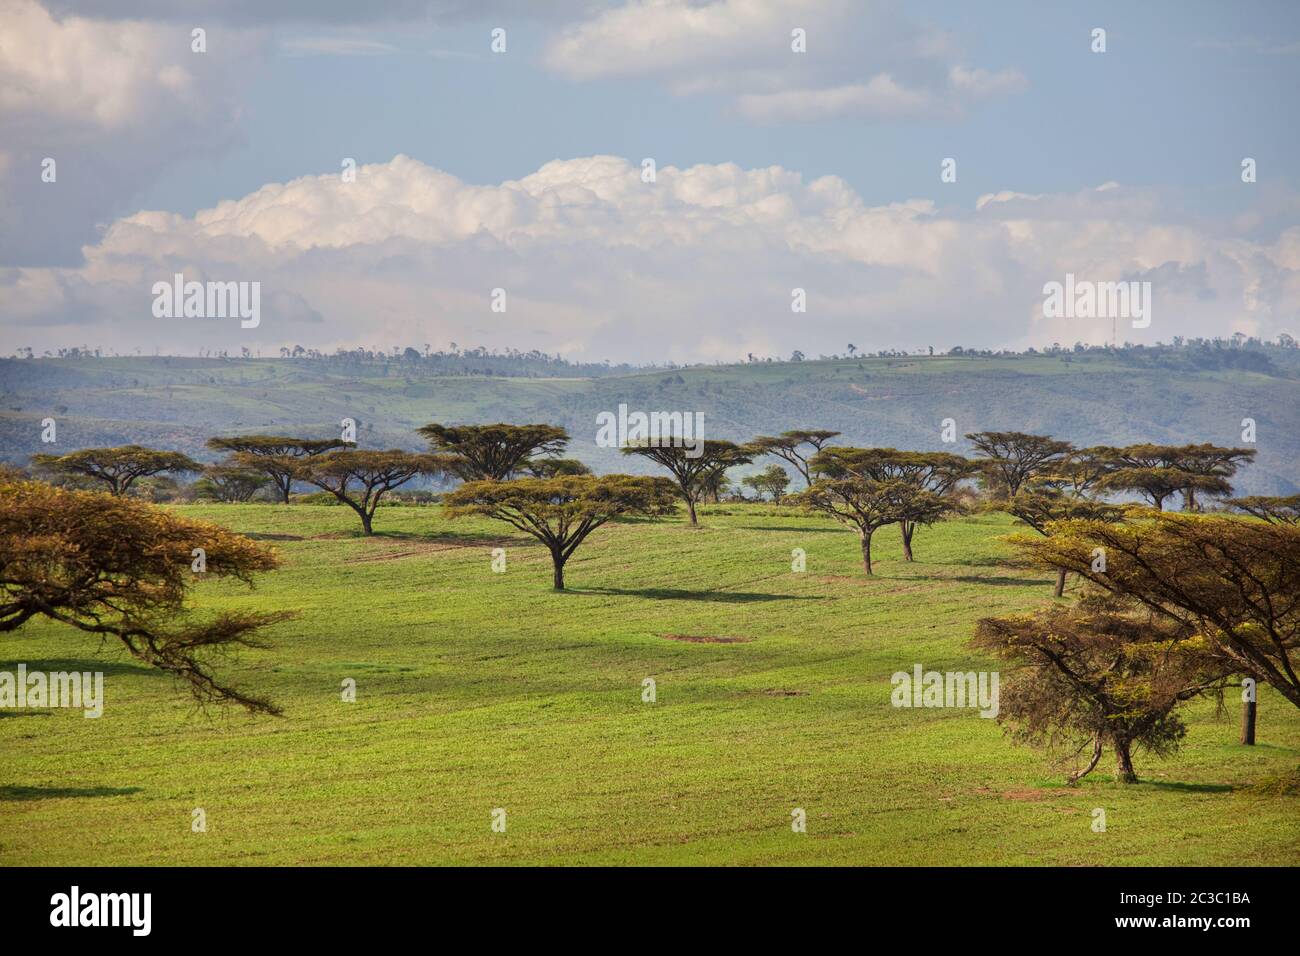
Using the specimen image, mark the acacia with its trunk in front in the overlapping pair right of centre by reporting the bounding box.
[794,476,953,575]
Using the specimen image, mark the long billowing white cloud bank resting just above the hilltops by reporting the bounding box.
[0,156,1300,362]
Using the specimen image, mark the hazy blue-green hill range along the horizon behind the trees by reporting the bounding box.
[0,349,1300,494]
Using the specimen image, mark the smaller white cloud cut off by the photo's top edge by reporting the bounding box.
[543,0,1027,122]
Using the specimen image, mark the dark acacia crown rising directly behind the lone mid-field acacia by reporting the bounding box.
[417,423,569,481]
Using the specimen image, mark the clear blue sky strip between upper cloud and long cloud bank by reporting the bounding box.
[134,3,1300,227]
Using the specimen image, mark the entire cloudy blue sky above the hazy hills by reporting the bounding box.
[0,0,1300,362]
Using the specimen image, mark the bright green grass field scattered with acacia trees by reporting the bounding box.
[0,505,1300,865]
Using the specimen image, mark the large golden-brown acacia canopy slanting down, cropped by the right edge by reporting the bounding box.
[1013,512,1300,706]
